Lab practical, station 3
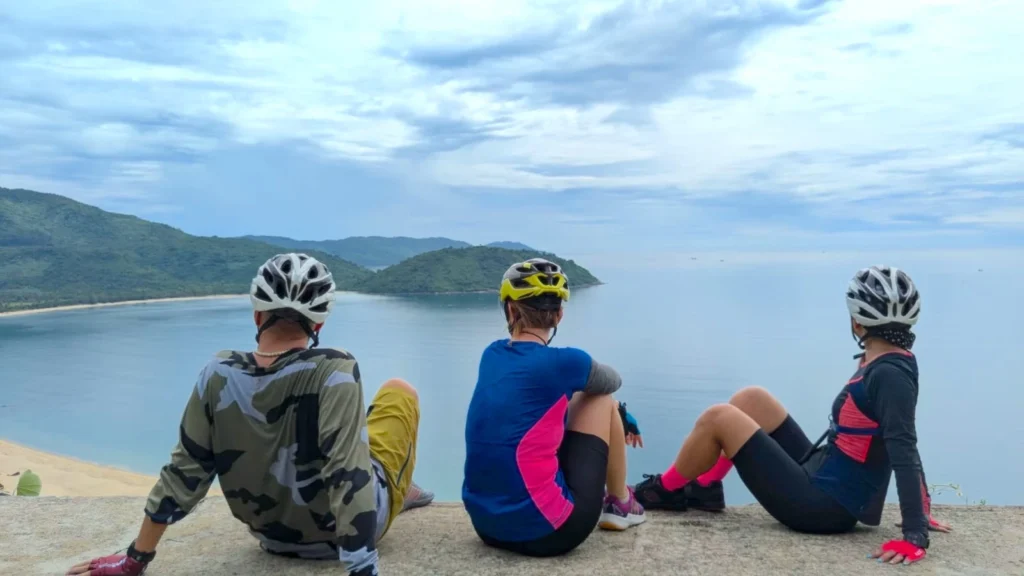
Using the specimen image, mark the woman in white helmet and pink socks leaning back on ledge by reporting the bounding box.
[636,266,949,564]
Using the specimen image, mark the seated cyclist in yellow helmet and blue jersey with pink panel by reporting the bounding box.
[462,258,644,557]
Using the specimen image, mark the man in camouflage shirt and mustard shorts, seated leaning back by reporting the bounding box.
[69,254,419,576]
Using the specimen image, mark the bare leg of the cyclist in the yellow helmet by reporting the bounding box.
[568,393,629,500]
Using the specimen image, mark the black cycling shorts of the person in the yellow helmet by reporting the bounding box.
[477,430,608,557]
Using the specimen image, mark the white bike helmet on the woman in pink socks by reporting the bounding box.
[846,266,921,328]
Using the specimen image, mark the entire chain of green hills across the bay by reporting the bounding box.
[0,188,600,312]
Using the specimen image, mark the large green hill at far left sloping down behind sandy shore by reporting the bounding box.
[0,188,373,311]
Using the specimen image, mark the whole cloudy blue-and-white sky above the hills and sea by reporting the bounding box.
[0,0,1024,253]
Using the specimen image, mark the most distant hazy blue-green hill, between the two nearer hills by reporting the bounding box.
[245,236,470,269]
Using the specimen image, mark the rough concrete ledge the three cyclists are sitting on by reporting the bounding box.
[0,497,1024,576]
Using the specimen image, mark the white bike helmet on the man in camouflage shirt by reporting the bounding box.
[249,252,336,346]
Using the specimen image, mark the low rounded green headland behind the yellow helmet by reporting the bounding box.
[355,246,600,294]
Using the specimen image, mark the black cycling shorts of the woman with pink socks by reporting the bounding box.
[732,417,857,534]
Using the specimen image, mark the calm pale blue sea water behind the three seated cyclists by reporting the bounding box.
[0,254,1024,504]
